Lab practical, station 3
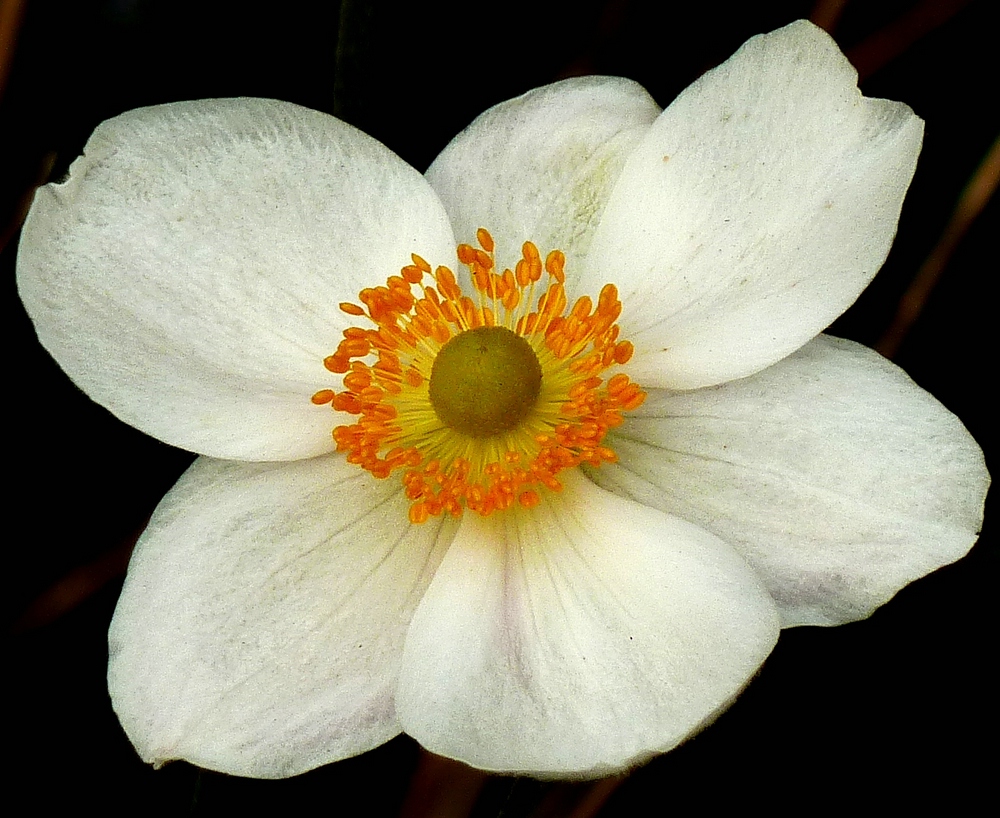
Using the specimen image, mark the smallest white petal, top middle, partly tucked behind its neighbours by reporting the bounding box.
[427,77,660,270]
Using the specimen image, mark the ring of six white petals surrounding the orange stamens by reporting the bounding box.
[18,23,989,777]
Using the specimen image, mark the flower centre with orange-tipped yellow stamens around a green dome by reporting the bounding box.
[312,229,646,523]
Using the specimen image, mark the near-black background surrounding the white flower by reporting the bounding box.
[0,0,1000,818]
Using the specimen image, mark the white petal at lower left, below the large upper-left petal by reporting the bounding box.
[108,456,456,778]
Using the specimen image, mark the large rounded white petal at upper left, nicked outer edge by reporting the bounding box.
[18,99,455,460]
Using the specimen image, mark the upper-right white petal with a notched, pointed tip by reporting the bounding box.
[583,21,923,389]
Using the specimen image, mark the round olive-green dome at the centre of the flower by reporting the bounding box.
[430,327,542,437]
